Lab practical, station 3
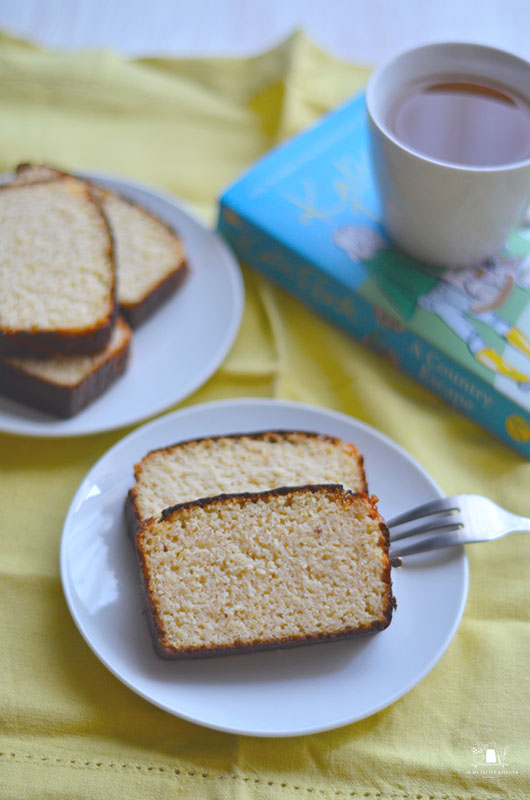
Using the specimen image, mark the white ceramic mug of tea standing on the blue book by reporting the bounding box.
[366,42,530,268]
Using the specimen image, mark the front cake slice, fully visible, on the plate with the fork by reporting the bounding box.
[136,485,394,659]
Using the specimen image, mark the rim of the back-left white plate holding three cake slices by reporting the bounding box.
[0,170,245,439]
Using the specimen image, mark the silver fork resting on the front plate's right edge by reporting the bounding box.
[387,494,530,559]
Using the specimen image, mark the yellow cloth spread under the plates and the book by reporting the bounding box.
[0,35,530,800]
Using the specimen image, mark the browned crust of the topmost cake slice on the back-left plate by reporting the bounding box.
[0,178,118,358]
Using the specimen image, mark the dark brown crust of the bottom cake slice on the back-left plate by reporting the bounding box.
[0,321,131,419]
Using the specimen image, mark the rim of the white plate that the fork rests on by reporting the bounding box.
[59,397,469,738]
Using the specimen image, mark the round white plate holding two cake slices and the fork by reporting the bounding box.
[61,399,468,736]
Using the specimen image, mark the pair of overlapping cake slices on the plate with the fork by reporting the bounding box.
[126,431,394,658]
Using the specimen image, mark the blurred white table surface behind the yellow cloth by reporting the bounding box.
[0,0,530,64]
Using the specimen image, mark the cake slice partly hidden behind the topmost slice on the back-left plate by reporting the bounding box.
[17,164,187,328]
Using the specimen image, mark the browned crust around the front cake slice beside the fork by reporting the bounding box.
[135,484,396,660]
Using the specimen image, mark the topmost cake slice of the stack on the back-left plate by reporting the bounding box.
[0,176,117,356]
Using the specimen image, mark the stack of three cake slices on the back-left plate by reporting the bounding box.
[0,164,186,417]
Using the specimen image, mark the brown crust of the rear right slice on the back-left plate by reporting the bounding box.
[16,163,188,328]
